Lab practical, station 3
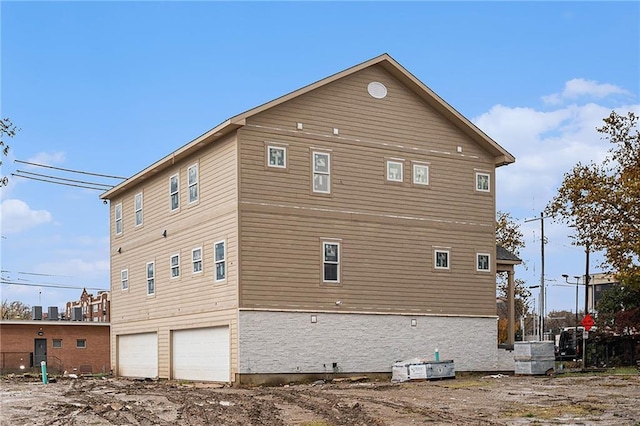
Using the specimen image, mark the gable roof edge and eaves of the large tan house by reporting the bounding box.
[100,53,515,200]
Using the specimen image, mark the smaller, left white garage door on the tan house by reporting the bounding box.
[118,333,158,378]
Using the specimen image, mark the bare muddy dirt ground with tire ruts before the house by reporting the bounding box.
[0,373,640,426]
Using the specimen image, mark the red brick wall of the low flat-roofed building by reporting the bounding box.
[0,321,111,374]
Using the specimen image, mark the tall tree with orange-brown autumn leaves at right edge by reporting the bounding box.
[545,111,640,284]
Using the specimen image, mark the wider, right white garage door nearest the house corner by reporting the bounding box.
[171,327,231,382]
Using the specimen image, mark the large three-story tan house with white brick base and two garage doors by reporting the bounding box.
[102,54,514,383]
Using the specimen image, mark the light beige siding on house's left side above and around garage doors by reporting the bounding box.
[111,133,238,377]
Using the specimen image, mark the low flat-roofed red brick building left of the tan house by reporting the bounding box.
[0,320,111,374]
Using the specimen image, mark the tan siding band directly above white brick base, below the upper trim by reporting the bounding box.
[241,209,495,315]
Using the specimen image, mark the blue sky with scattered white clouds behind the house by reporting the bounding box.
[0,1,640,311]
